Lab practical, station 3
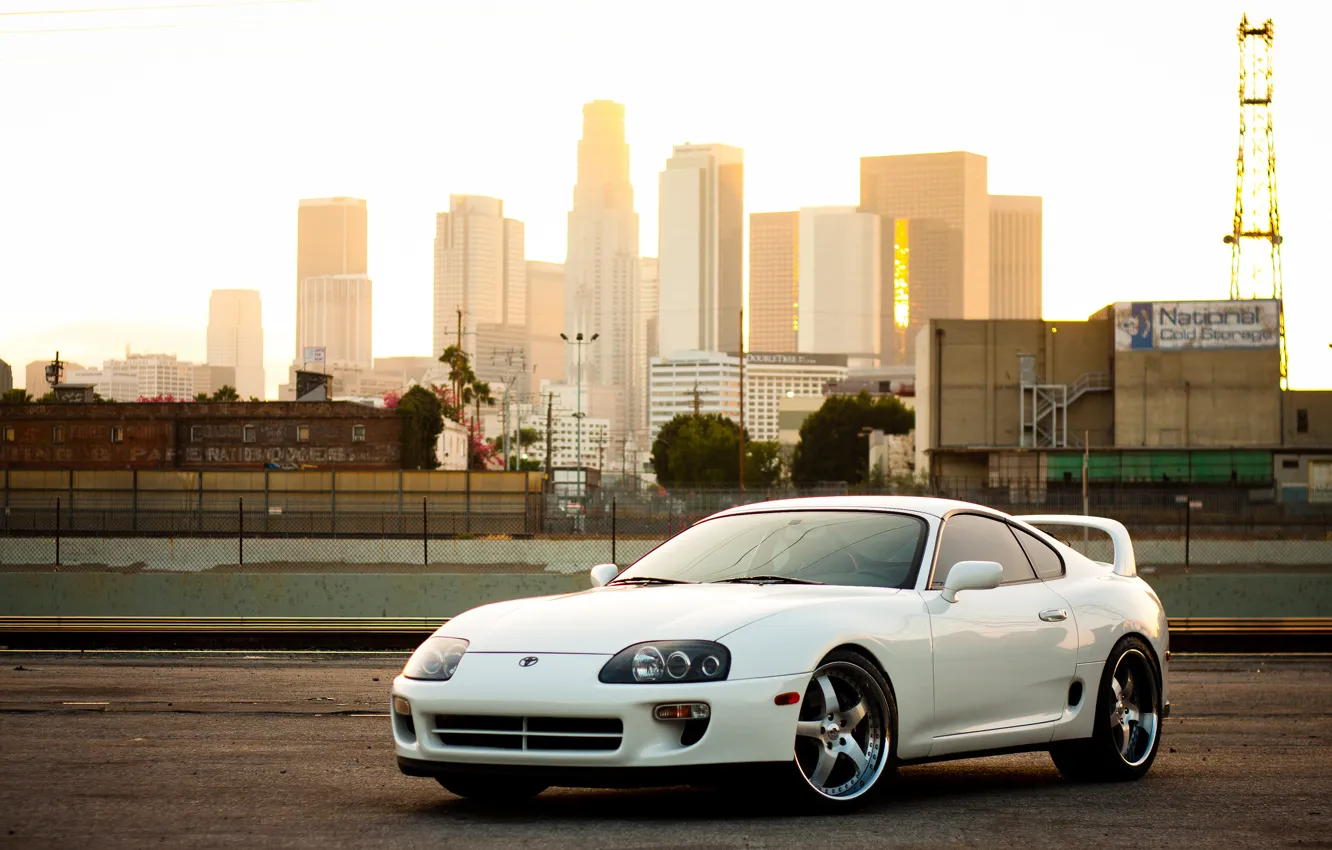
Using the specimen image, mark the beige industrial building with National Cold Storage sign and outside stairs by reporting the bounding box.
[915,300,1332,501]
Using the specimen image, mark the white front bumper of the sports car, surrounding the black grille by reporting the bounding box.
[390,653,810,785]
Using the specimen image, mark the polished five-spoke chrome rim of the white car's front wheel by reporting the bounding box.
[795,661,891,799]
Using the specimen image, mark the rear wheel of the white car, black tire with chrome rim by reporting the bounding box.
[1050,636,1162,782]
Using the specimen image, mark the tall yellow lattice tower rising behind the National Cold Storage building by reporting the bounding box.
[1225,15,1287,389]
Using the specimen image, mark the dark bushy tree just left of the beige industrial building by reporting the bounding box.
[791,390,915,488]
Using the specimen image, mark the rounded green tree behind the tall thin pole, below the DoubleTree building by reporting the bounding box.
[653,413,782,488]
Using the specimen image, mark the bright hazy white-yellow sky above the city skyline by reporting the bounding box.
[0,0,1332,392]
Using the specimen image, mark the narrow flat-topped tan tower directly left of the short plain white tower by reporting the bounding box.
[749,212,801,352]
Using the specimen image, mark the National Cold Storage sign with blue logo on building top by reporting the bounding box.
[1115,300,1281,352]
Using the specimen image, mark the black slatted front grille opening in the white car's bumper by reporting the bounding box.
[432,714,625,751]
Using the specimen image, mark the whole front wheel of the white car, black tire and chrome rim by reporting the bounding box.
[778,649,898,813]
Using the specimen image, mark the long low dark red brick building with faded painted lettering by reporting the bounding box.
[0,401,401,470]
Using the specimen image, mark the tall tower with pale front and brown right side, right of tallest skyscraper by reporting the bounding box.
[658,144,745,356]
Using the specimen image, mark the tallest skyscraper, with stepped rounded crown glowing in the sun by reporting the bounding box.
[565,100,647,437]
